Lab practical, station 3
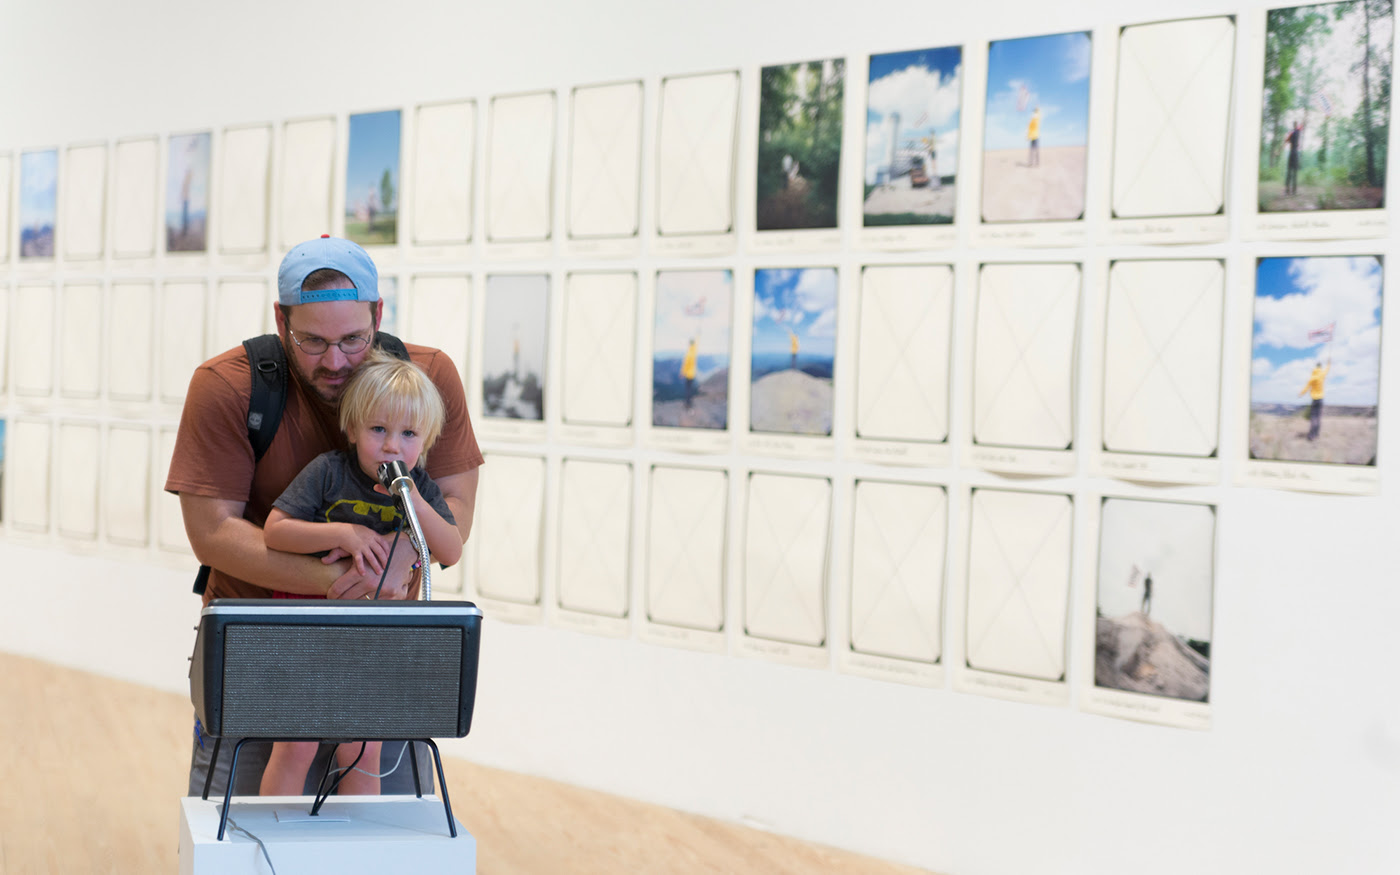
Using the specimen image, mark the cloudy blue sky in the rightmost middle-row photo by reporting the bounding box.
[1250,255,1382,406]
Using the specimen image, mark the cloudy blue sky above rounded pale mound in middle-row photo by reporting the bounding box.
[753,267,836,358]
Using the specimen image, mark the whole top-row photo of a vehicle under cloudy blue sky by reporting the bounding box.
[864,46,962,228]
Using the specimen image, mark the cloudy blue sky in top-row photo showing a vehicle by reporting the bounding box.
[865,46,962,185]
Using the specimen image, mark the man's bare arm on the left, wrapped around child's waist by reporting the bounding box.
[179,493,412,599]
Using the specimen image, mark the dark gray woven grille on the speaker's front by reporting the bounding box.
[223,624,462,739]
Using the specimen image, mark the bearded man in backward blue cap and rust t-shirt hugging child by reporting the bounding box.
[165,237,483,795]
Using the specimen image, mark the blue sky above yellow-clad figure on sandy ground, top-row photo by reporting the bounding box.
[983,32,1092,151]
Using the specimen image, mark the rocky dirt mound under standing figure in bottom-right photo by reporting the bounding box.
[1093,612,1211,701]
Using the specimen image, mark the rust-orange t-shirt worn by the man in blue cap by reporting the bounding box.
[165,337,484,605]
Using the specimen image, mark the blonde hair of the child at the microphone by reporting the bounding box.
[340,347,447,463]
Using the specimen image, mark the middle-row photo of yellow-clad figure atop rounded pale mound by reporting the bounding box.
[749,267,836,434]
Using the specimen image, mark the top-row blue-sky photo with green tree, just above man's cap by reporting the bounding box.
[346,109,402,246]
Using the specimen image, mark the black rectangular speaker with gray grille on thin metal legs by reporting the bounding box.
[189,599,482,741]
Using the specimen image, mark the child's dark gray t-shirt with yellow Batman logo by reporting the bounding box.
[273,449,456,535]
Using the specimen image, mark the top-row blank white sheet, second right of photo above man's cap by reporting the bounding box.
[486,91,554,242]
